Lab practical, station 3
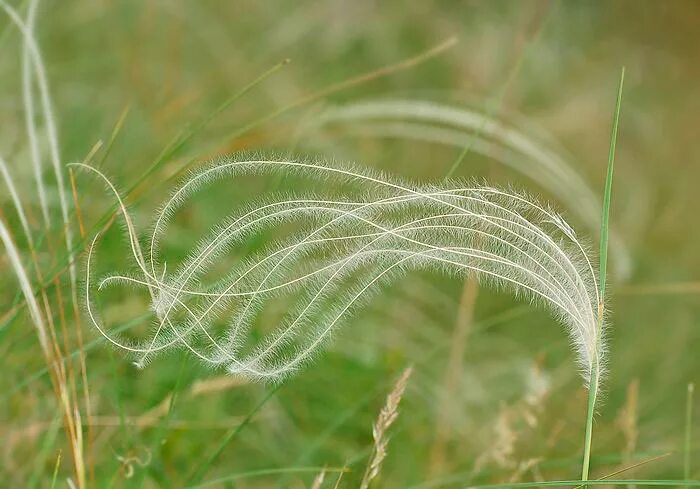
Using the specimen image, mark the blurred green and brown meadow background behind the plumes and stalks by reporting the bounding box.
[0,0,700,487]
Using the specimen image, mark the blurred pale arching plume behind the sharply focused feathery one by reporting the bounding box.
[307,98,631,278]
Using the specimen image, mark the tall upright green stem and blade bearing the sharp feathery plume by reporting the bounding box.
[581,67,625,481]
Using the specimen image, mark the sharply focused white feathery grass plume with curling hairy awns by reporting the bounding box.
[76,154,604,382]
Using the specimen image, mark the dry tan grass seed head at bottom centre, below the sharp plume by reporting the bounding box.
[360,367,413,489]
